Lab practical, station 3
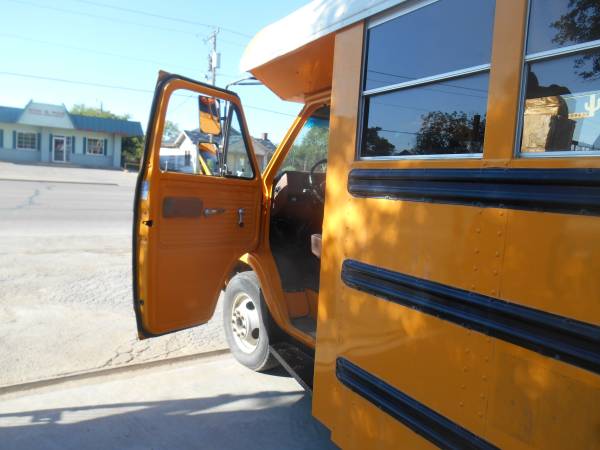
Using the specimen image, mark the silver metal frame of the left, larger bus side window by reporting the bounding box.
[355,0,497,161]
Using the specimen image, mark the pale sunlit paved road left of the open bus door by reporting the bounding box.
[0,163,225,386]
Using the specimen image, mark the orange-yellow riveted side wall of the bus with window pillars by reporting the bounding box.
[313,0,600,449]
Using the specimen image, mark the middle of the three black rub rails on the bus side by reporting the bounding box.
[342,260,600,374]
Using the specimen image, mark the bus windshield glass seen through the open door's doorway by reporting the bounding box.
[278,106,329,174]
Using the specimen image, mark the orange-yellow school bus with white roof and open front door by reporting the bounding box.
[133,0,600,449]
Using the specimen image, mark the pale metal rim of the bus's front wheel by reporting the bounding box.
[231,292,260,353]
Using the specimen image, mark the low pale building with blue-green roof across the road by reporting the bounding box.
[0,101,143,168]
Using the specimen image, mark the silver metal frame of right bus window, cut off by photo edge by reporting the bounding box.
[513,0,600,159]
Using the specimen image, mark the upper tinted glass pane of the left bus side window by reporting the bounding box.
[365,0,495,89]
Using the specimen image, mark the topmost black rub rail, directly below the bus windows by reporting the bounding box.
[348,168,600,216]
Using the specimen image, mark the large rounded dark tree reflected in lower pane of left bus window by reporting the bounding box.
[414,111,485,154]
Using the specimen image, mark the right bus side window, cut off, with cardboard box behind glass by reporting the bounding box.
[520,0,600,156]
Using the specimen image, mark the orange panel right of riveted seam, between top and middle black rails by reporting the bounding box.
[500,211,600,326]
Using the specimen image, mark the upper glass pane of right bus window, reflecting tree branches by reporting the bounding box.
[527,0,600,53]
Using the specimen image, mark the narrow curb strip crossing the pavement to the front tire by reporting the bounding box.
[0,349,229,396]
